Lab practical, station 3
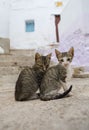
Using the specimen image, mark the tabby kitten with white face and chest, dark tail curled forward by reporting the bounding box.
[40,47,74,101]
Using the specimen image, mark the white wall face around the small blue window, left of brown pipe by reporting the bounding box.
[10,9,55,49]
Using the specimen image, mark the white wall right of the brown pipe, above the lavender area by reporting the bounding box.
[59,0,83,36]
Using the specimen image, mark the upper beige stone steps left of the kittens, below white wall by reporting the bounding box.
[0,50,35,67]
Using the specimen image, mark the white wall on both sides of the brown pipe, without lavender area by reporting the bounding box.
[0,0,89,49]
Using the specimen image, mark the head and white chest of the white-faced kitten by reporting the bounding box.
[55,47,74,90]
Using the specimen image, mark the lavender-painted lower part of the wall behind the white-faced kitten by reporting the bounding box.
[37,29,89,66]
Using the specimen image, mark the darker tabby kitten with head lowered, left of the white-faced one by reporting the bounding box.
[15,53,51,101]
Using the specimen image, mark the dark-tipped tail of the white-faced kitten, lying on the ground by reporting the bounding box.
[40,85,72,101]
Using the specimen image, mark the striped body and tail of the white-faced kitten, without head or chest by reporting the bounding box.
[40,64,72,101]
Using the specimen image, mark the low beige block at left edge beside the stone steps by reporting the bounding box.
[0,38,10,54]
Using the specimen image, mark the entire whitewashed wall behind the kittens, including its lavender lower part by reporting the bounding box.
[0,0,89,65]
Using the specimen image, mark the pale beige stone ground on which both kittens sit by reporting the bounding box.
[0,49,89,130]
